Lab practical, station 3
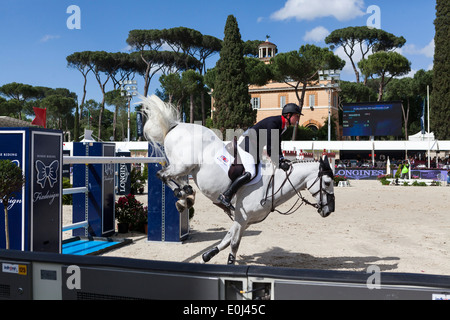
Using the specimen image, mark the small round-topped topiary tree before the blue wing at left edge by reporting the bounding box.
[0,160,25,249]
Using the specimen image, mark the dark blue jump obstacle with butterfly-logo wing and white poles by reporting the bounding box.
[0,128,189,253]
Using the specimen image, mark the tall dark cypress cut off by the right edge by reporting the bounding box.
[430,0,450,140]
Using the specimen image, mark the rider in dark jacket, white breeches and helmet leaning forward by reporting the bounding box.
[217,103,301,210]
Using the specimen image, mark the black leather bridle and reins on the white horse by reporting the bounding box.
[260,160,334,215]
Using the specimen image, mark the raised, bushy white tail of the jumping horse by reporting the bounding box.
[141,95,180,154]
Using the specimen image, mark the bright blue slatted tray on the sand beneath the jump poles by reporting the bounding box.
[62,237,131,256]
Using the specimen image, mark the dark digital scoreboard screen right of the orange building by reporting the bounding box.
[342,101,402,137]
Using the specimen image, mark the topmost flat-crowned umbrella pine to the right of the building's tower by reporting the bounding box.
[325,26,406,83]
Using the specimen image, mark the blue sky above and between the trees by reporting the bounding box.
[0,0,436,114]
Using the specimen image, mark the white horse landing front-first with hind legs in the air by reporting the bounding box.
[142,96,334,264]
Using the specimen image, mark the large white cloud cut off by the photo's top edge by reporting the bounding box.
[271,0,366,21]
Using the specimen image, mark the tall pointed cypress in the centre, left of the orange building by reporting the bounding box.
[213,15,256,133]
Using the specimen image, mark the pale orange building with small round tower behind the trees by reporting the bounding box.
[212,40,341,137]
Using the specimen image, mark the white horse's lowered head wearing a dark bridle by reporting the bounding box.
[308,156,334,218]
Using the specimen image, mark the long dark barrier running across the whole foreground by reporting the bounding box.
[0,250,450,300]
